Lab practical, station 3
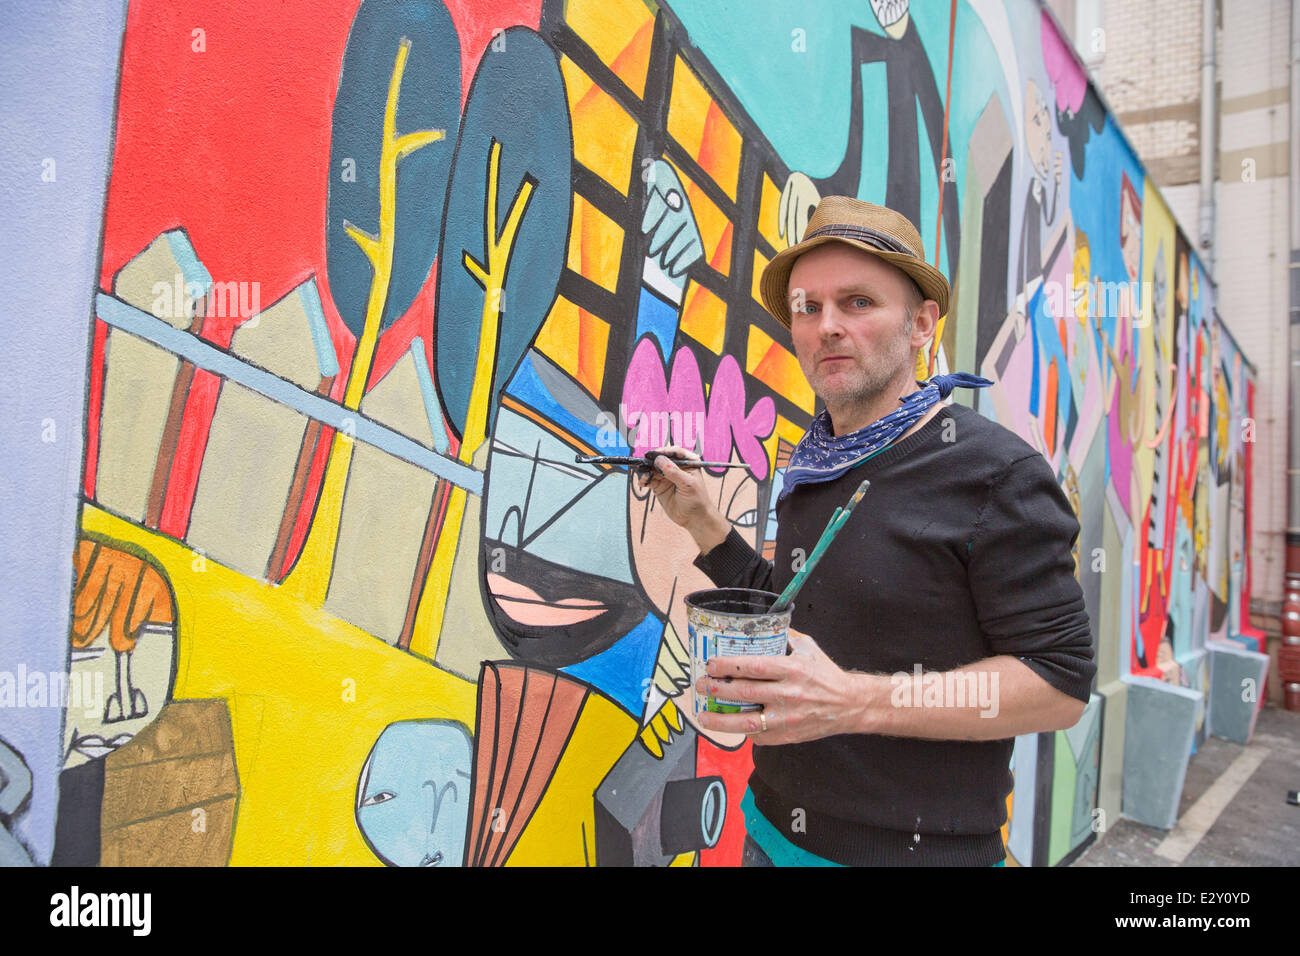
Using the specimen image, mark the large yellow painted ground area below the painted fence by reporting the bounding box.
[82,505,478,866]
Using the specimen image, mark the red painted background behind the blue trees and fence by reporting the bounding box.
[92,0,541,546]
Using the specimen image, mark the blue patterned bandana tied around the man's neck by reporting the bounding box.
[777,372,993,499]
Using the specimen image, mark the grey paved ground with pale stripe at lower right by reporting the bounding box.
[1074,705,1300,866]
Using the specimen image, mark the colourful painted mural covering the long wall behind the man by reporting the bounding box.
[0,0,1255,866]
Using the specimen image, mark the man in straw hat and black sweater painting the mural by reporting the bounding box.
[650,196,1095,866]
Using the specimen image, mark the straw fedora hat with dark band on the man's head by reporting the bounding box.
[759,196,948,328]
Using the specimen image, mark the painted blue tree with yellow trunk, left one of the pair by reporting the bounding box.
[285,0,460,605]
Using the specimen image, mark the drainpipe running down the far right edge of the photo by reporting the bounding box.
[1278,0,1300,710]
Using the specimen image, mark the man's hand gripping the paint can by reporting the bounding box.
[696,630,865,747]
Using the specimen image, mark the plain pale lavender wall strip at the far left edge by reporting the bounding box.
[0,0,126,864]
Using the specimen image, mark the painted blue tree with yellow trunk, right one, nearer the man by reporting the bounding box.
[411,27,573,657]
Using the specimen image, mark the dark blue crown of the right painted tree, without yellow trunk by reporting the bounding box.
[433,27,572,434]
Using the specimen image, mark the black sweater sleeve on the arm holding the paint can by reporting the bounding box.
[969,454,1097,702]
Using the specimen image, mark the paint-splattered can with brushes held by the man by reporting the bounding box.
[685,588,793,714]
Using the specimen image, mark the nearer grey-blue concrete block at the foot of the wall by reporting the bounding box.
[1123,678,1205,830]
